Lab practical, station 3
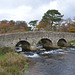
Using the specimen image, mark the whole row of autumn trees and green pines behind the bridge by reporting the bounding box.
[0,10,75,34]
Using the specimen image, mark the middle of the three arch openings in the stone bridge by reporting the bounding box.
[37,38,52,49]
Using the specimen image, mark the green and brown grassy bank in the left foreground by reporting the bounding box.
[0,47,28,75]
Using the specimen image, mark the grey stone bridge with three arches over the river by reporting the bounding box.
[0,31,75,47]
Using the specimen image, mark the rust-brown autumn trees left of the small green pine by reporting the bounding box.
[0,20,28,34]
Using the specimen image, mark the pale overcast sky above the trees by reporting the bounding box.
[0,0,75,22]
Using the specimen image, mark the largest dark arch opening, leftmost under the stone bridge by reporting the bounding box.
[15,40,30,52]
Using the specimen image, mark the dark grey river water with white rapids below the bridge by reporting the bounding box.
[23,48,75,75]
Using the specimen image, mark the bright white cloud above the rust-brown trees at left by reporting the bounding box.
[0,6,32,20]
